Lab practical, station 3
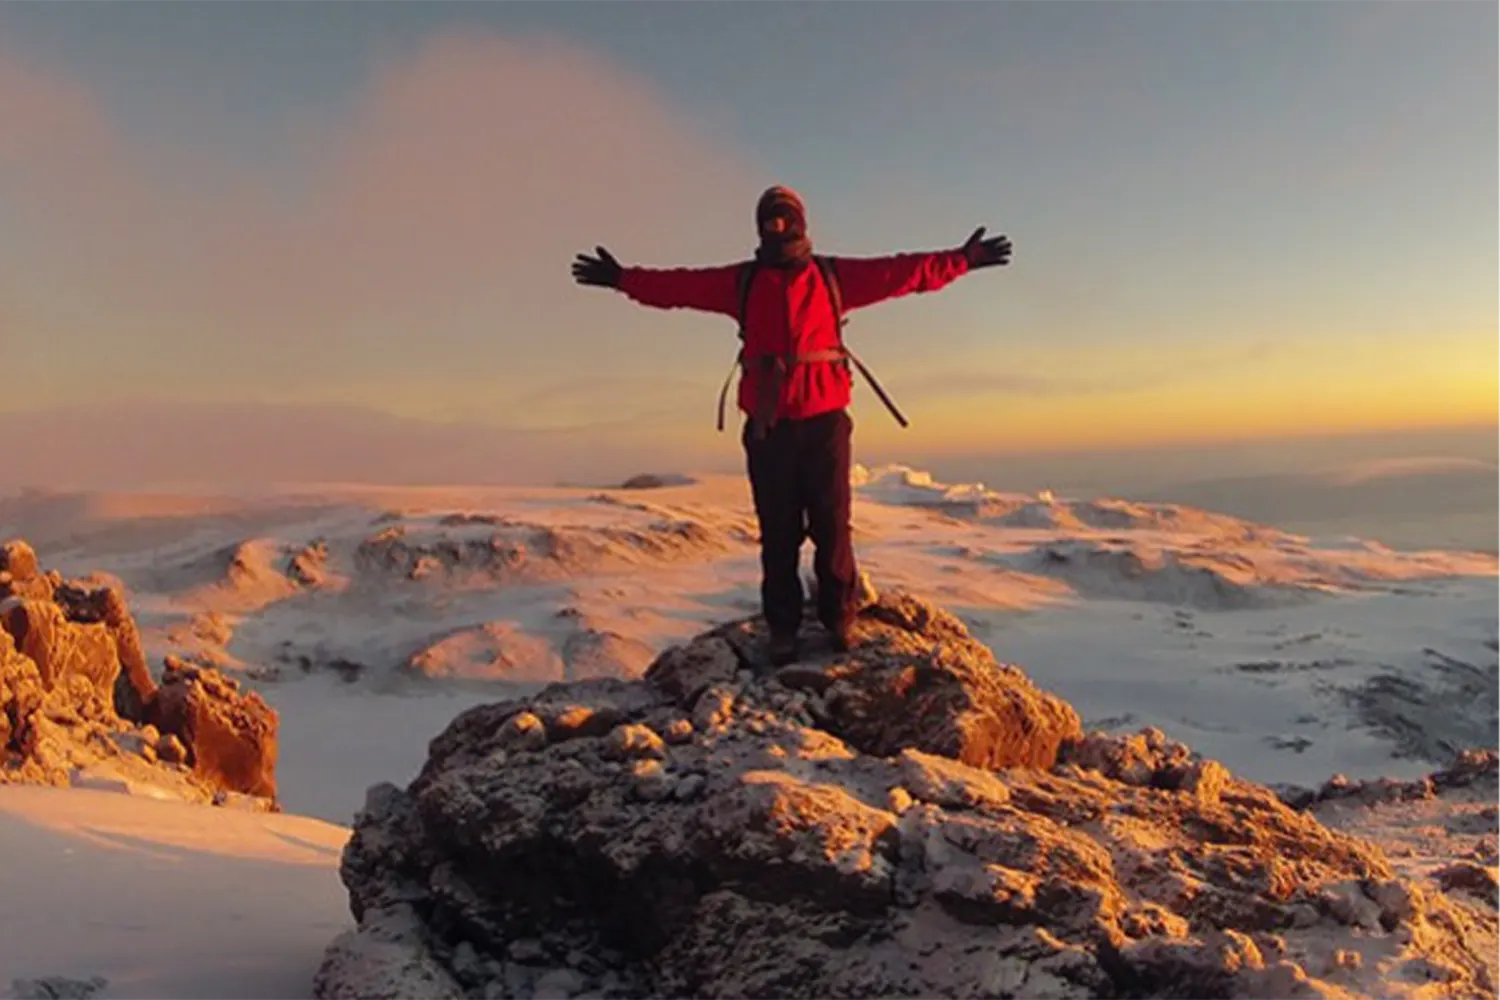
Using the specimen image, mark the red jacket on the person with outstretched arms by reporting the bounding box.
[620,250,969,420]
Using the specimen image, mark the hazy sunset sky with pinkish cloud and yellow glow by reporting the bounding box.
[0,0,1500,484]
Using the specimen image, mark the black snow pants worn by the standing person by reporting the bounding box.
[744,409,857,637]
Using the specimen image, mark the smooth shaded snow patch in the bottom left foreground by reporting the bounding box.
[0,786,351,1000]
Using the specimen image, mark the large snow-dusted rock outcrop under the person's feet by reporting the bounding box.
[317,595,1500,1000]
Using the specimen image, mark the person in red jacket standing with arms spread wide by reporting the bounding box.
[573,186,1011,666]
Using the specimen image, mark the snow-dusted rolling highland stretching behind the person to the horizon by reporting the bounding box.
[0,465,1500,822]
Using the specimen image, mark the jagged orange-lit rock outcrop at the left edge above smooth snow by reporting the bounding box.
[0,541,278,808]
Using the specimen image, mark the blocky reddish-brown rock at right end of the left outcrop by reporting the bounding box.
[152,661,278,799]
